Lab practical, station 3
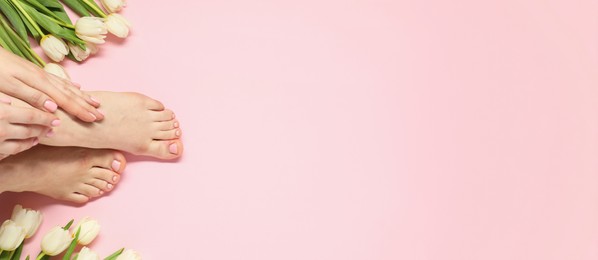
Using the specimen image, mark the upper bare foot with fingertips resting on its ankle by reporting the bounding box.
[5,91,183,159]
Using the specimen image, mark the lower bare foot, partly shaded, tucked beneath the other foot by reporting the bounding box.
[0,145,126,203]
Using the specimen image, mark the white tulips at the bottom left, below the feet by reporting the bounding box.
[0,205,141,260]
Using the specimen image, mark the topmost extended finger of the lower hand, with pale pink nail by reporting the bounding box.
[0,104,60,127]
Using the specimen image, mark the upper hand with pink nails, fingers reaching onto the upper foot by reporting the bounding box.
[0,48,104,122]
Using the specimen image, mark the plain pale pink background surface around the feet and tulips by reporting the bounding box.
[0,0,598,260]
